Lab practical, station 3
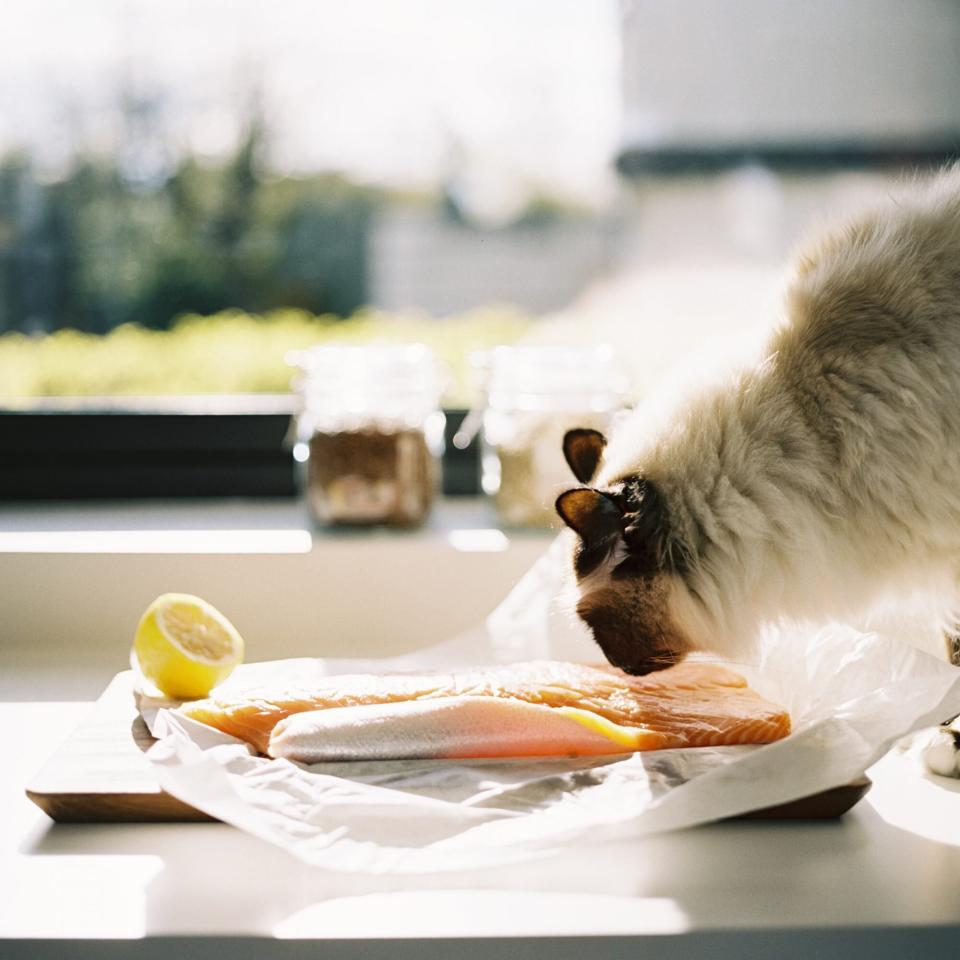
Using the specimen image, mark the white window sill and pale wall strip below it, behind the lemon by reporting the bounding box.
[0,498,552,699]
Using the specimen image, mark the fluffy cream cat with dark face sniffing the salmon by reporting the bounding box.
[556,165,960,773]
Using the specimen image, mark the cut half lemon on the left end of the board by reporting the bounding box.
[133,593,243,700]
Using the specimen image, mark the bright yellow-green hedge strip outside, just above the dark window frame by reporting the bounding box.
[0,307,533,405]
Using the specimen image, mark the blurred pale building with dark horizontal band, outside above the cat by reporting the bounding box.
[604,0,960,284]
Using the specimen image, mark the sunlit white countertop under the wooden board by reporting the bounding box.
[0,702,960,960]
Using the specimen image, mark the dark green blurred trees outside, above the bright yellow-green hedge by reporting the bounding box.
[0,112,382,333]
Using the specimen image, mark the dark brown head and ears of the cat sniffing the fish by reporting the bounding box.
[556,429,694,674]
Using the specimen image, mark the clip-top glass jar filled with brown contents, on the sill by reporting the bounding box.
[288,344,444,526]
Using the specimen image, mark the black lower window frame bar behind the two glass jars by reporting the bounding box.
[0,396,480,502]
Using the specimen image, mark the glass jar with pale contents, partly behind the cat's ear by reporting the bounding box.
[482,346,627,527]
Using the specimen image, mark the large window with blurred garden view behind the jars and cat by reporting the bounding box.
[0,0,960,498]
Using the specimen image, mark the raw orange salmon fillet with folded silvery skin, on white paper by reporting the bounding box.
[179,661,790,763]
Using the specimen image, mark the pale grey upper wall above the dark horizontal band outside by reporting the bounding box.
[623,0,960,146]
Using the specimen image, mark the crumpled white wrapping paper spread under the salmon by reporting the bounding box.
[141,541,960,873]
